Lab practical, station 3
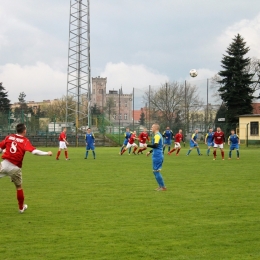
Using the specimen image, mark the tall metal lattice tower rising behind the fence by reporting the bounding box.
[66,0,91,132]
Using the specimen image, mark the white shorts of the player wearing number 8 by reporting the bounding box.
[0,160,22,186]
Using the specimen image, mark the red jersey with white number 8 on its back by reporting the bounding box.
[0,134,36,168]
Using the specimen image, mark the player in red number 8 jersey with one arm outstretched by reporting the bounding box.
[0,124,52,213]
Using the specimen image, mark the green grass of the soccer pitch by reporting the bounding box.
[0,146,260,260]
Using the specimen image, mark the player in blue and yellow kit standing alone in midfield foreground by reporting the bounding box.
[145,124,166,191]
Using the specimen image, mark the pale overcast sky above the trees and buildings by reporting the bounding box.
[0,0,260,105]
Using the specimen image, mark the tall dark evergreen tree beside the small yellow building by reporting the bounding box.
[218,34,254,127]
